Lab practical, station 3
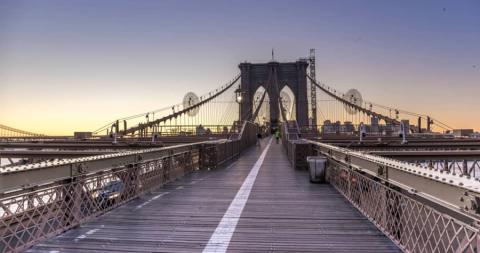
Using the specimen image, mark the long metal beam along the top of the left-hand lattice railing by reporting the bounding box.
[0,122,257,195]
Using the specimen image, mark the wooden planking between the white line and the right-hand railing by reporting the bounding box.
[229,141,400,252]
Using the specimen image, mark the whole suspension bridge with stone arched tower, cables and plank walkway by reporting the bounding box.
[0,53,480,253]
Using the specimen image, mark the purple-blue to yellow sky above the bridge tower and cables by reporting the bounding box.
[0,0,480,135]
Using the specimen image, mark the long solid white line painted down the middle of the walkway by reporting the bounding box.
[203,139,272,253]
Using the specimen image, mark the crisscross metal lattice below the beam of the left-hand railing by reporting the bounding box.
[0,147,199,252]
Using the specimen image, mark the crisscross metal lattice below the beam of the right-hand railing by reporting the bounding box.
[327,165,480,253]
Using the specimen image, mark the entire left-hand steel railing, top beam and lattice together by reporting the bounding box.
[0,123,255,253]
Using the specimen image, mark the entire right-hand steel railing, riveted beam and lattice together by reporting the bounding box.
[283,121,480,253]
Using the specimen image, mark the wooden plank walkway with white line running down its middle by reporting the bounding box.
[28,140,400,253]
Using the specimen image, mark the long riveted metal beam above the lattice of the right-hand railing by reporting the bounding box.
[310,141,480,218]
